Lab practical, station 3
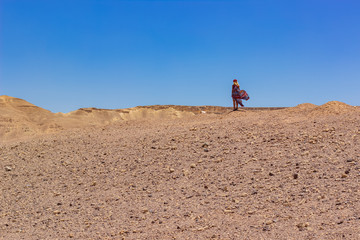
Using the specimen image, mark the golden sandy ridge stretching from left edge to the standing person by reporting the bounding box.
[0,95,232,142]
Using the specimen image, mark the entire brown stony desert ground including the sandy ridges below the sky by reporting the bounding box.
[0,96,360,240]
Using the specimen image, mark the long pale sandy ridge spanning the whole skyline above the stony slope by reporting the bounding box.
[0,95,359,141]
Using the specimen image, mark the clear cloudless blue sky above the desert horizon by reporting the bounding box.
[0,0,360,112]
